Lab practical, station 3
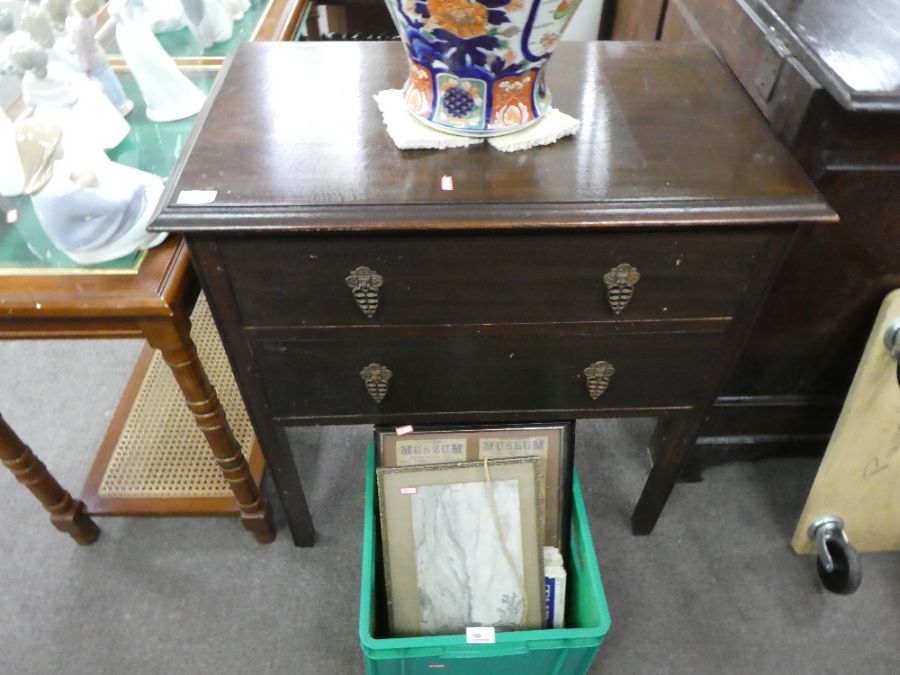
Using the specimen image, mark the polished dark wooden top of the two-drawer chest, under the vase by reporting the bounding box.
[154,43,833,231]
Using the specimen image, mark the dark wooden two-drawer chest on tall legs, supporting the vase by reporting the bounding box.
[153,43,835,545]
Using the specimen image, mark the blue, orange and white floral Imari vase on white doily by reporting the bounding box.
[385,0,580,136]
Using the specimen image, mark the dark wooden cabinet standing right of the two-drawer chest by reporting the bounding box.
[604,0,900,469]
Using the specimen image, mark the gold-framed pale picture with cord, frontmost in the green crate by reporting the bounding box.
[376,457,544,637]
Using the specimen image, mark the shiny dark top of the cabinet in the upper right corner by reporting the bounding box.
[748,0,900,111]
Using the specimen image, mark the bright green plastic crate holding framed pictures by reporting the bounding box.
[359,444,610,675]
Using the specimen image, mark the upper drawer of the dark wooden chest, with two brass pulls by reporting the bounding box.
[220,230,767,327]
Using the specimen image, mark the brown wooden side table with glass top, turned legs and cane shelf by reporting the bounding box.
[0,0,308,544]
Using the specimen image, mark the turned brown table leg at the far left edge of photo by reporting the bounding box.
[0,416,100,544]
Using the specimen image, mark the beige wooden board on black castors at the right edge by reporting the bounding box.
[792,290,900,554]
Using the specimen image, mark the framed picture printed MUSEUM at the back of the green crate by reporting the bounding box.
[375,421,575,556]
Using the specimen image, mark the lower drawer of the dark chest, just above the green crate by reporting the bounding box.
[251,333,721,418]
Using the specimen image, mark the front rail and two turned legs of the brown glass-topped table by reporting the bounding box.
[0,238,275,544]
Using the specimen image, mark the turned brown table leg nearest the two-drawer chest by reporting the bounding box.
[143,317,275,544]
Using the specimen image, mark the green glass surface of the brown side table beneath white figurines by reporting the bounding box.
[0,68,217,275]
